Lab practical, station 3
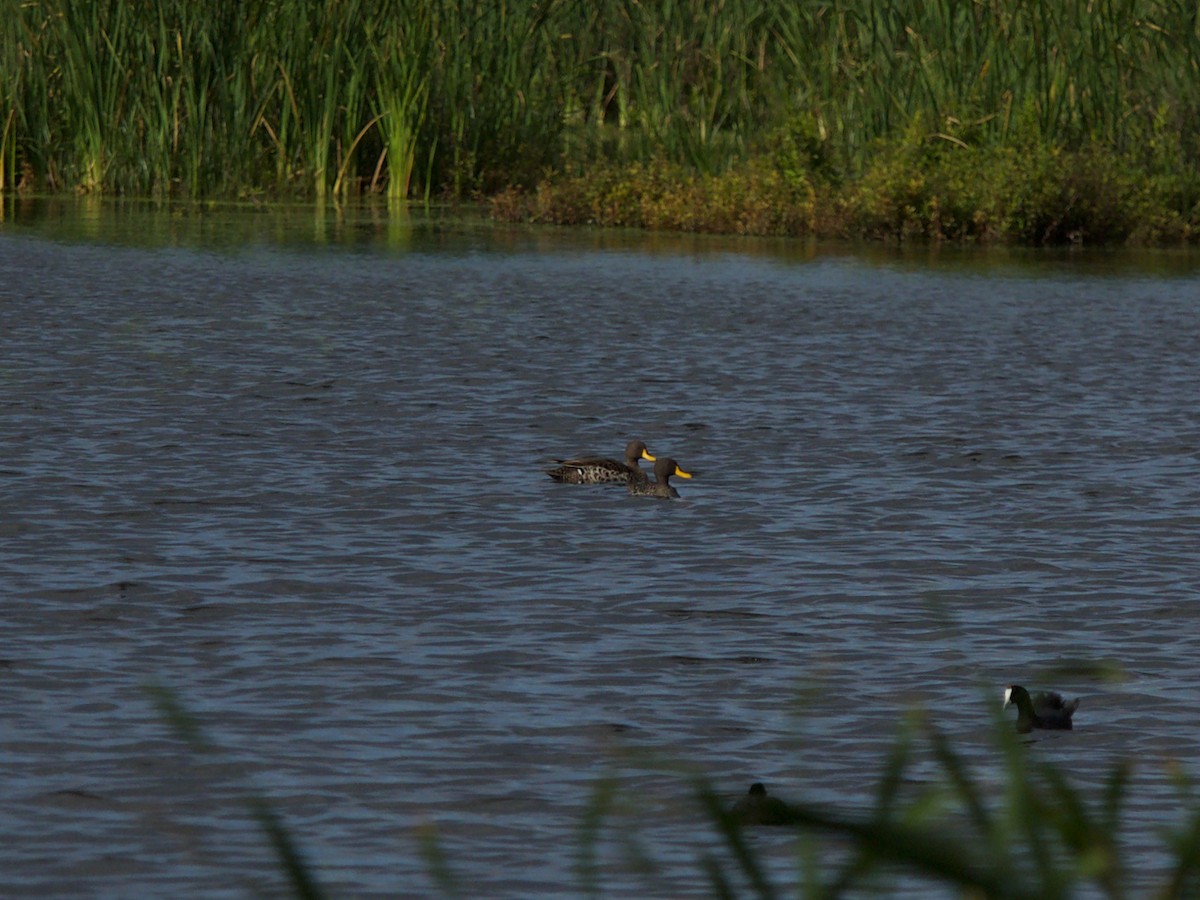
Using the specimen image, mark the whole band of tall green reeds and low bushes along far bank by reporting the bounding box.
[0,0,1200,242]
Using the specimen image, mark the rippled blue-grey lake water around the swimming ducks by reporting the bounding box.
[0,203,1200,898]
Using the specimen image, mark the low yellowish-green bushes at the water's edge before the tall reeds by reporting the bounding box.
[491,138,1200,245]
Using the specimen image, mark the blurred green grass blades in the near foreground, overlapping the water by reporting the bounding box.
[152,689,1200,900]
